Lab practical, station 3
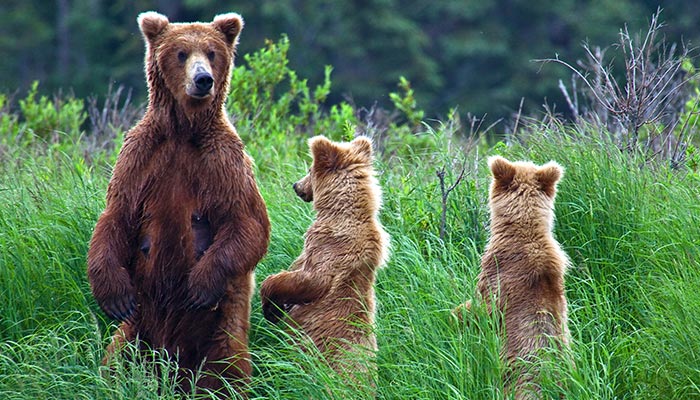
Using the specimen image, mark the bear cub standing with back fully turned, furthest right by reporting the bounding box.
[455,156,569,399]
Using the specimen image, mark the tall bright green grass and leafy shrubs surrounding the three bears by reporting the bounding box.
[0,40,700,400]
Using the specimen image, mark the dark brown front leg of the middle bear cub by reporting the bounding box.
[260,270,330,324]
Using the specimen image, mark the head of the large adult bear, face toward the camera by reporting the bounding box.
[138,11,243,115]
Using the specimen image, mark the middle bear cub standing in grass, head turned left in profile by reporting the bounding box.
[260,136,389,384]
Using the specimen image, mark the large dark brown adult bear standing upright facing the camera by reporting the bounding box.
[87,12,270,396]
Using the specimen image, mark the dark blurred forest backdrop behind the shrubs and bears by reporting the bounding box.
[0,0,700,119]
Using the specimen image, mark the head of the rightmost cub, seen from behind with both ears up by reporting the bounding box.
[488,156,564,228]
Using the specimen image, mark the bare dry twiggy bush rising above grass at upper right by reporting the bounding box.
[539,10,696,166]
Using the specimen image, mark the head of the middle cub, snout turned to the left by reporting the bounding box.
[293,136,381,210]
